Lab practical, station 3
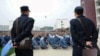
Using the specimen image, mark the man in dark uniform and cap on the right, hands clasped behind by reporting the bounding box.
[70,6,98,56]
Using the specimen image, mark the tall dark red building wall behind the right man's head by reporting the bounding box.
[81,0,97,25]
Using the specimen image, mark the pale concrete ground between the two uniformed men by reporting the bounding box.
[34,47,72,56]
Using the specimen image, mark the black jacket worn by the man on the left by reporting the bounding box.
[11,14,34,42]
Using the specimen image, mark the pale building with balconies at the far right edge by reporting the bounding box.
[95,0,100,29]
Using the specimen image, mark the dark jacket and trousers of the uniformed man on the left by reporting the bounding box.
[11,14,34,56]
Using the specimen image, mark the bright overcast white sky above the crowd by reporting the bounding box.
[0,0,80,27]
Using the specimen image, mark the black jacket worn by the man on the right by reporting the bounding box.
[70,16,98,47]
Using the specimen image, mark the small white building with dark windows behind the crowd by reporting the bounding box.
[55,19,69,29]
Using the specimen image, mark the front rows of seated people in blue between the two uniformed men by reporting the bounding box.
[32,33,71,49]
